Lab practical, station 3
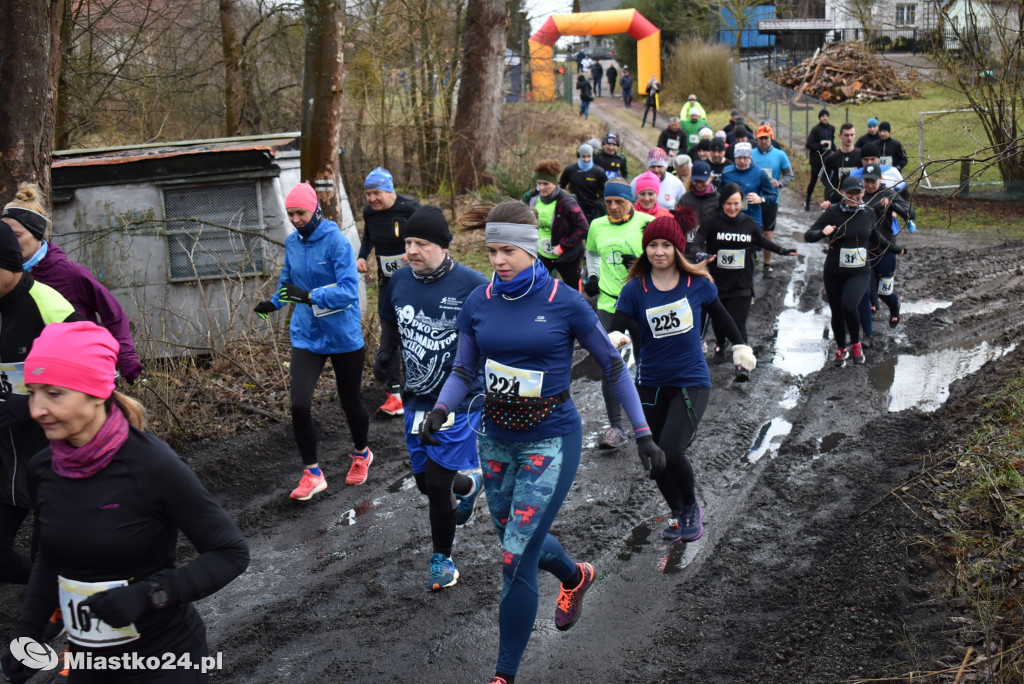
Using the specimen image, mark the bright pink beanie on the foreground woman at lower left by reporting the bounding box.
[25,320,121,399]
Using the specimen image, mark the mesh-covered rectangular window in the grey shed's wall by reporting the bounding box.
[164,182,264,281]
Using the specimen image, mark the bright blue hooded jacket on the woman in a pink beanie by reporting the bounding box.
[270,218,364,354]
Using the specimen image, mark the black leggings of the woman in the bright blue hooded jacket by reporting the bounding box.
[292,347,370,466]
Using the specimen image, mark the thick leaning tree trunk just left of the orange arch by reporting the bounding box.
[452,0,506,191]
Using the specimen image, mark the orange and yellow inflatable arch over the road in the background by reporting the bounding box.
[529,9,662,102]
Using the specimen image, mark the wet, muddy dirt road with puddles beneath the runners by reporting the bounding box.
[0,94,1024,684]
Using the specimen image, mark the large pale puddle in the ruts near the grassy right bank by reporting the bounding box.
[869,342,1017,412]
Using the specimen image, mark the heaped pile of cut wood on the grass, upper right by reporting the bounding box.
[775,42,918,102]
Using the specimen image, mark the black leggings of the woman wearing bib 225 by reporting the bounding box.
[637,385,711,516]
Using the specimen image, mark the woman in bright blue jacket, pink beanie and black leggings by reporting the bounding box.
[256,183,374,501]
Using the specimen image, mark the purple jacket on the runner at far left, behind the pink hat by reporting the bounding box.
[32,242,142,381]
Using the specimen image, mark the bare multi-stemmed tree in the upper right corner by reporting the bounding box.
[931,0,1024,189]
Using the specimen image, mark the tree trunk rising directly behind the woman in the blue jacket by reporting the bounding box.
[301,0,345,221]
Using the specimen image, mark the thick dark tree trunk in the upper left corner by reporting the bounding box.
[0,0,65,203]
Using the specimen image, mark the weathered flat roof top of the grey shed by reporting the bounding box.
[51,132,299,169]
